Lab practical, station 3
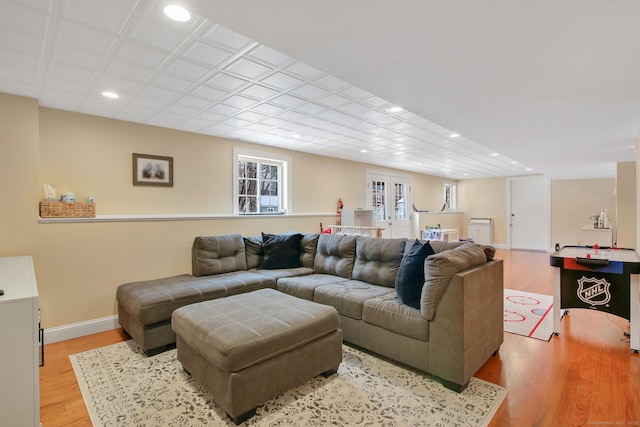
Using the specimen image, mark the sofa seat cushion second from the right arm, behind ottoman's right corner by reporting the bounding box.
[313,280,395,320]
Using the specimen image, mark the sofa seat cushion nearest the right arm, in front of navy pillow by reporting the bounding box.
[362,293,429,341]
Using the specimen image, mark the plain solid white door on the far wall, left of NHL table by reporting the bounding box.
[508,176,550,251]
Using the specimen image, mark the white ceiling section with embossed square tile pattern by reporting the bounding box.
[0,0,532,179]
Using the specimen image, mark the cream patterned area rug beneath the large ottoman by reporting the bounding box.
[69,341,507,427]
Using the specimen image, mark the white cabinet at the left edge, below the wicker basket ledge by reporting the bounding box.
[0,256,40,427]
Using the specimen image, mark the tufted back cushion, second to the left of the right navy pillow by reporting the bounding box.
[313,234,357,279]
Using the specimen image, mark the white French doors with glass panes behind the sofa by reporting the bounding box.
[366,172,412,238]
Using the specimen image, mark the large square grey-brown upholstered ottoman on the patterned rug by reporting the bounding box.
[171,289,342,424]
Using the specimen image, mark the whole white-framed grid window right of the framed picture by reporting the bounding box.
[233,149,291,215]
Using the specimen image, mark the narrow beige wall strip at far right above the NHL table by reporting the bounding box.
[614,162,637,249]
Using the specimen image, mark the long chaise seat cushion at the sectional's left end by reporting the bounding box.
[116,271,276,325]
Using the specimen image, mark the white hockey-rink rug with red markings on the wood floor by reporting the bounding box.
[504,289,553,341]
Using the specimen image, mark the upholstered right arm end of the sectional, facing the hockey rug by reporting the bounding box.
[429,259,504,390]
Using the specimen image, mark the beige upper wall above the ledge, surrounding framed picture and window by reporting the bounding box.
[39,108,376,215]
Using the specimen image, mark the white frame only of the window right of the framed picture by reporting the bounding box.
[232,147,291,215]
